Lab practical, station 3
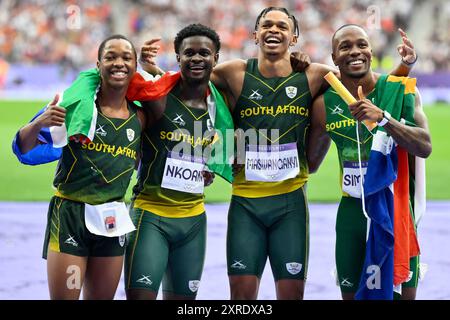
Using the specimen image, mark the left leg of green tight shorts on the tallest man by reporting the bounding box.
[227,196,267,278]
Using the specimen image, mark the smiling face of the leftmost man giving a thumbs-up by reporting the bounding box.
[97,39,137,89]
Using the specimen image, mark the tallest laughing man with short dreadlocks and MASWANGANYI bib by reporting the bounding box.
[141,7,418,299]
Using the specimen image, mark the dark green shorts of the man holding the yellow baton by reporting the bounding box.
[336,197,419,293]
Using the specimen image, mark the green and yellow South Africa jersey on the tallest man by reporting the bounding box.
[233,59,312,198]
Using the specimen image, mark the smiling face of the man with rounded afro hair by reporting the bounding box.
[177,36,219,83]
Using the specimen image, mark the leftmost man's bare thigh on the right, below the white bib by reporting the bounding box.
[83,255,123,300]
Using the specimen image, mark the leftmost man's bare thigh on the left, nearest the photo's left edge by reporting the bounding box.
[47,250,87,300]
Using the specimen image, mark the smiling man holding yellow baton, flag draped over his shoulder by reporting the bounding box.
[307,25,431,299]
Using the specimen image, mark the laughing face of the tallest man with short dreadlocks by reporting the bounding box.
[253,10,297,55]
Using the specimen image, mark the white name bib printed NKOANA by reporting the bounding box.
[161,152,205,194]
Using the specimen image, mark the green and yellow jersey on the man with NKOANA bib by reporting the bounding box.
[134,84,214,218]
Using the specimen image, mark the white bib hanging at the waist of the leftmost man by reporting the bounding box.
[84,201,136,237]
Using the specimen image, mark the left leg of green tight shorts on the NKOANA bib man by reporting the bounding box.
[125,209,169,292]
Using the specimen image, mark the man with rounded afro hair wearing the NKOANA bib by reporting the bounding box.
[125,24,220,299]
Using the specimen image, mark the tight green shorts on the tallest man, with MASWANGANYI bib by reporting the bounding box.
[227,188,309,281]
